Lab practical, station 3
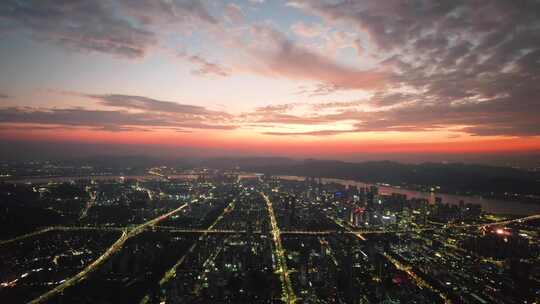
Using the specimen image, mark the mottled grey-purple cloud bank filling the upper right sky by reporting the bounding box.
[278,0,540,136]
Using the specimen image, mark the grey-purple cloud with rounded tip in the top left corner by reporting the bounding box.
[0,0,156,58]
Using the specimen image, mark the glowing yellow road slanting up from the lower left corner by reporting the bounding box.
[30,204,188,304]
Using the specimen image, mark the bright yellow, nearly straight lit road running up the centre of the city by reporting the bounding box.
[260,192,296,303]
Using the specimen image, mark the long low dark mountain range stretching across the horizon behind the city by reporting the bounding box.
[7,156,540,200]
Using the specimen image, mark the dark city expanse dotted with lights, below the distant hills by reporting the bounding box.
[0,167,540,303]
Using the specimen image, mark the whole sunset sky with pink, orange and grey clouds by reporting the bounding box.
[0,0,540,161]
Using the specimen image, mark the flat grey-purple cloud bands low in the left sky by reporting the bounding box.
[0,95,236,132]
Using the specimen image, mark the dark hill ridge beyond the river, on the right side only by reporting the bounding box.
[196,158,540,198]
